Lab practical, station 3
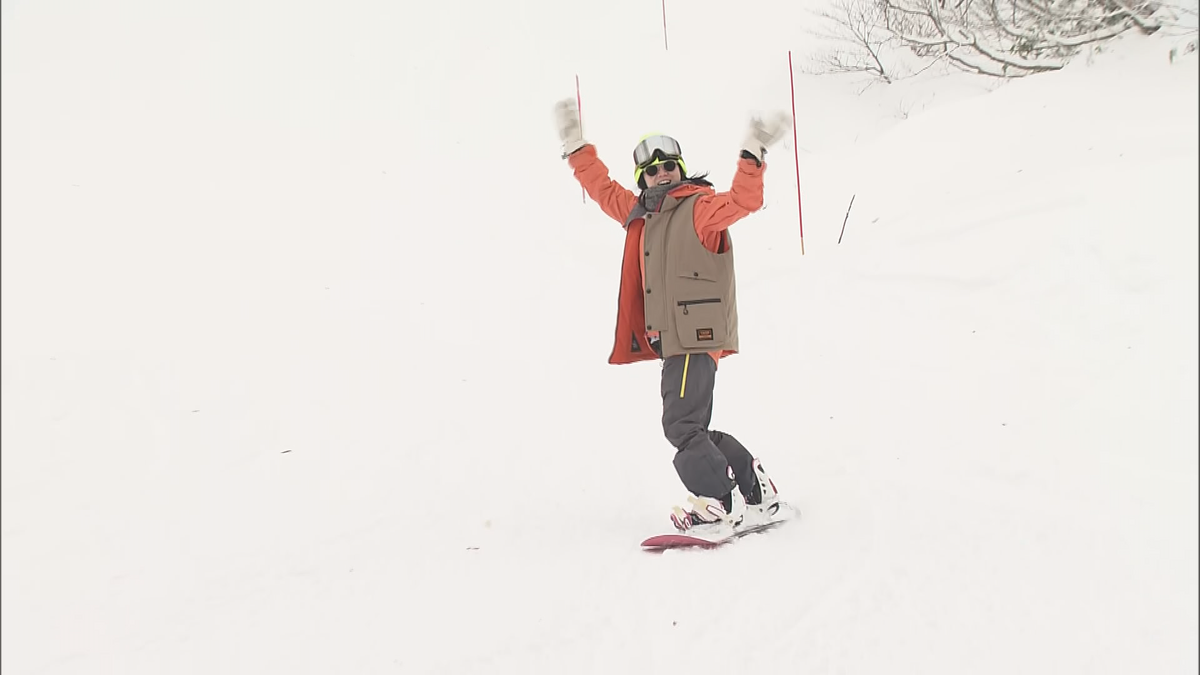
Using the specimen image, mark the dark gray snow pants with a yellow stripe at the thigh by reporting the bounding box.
[662,354,756,497]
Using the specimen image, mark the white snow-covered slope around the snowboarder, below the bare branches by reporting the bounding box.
[0,1,1200,675]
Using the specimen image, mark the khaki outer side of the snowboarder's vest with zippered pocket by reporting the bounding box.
[642,195,738,358]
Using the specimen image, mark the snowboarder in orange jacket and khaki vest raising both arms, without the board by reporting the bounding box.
[554,98,791,531]
